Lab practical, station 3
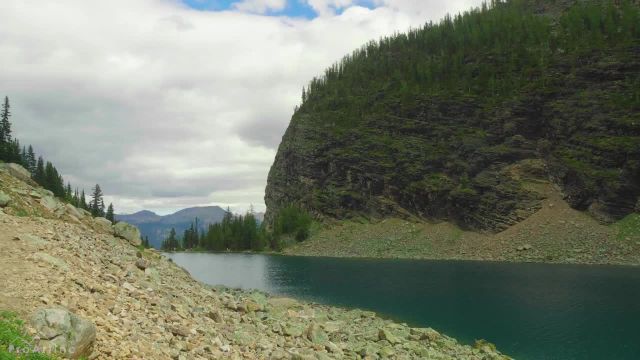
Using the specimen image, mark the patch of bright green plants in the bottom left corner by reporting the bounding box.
[0,311,56,360]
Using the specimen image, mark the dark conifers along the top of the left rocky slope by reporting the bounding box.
[0,96,115,222]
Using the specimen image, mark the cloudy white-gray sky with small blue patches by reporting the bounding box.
[0,0,478,214]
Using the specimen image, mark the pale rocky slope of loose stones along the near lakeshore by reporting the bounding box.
[0,165,509,359]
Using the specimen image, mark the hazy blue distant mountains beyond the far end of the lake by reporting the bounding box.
[116,206,226,248]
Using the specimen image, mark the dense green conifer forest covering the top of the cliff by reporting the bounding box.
[296,0,640,119]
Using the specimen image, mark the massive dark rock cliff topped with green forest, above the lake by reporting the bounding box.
[265,0,640,231]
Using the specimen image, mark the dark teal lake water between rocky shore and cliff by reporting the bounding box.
[168,253,640,360]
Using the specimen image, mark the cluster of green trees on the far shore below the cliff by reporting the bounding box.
[161,206,312,252]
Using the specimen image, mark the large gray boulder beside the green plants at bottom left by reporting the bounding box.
[31,309,96,359]
